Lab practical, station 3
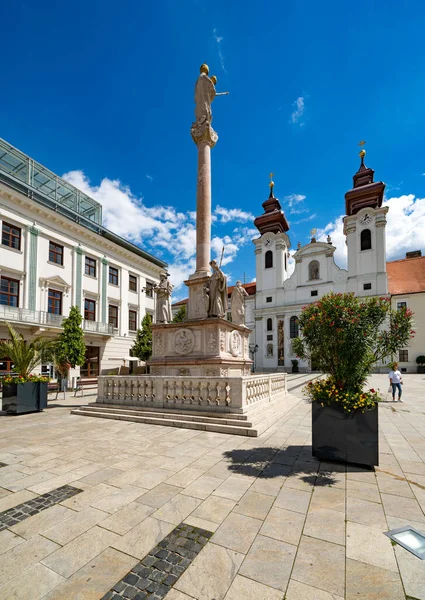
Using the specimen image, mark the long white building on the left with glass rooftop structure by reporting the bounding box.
[0,140,167,377]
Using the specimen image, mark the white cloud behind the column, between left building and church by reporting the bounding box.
[63,171,253,300]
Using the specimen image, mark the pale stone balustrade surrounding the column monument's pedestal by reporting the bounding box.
[96,373,286,413]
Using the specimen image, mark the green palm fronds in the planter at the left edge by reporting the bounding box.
[0,323,55,383]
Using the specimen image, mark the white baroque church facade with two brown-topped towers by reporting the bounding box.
[247,151,396,372]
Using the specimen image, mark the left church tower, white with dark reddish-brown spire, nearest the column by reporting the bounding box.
[254,175,291,298]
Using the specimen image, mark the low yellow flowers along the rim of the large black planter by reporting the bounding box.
[303,377,381,413]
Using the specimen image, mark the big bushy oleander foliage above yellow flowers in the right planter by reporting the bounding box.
[293,292,415,392]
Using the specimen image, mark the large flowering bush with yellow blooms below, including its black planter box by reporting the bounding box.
[294,293,415,466]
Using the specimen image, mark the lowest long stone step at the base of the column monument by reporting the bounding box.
[71,407,258,437]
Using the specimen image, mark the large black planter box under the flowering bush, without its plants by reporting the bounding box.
[311,402,379,467]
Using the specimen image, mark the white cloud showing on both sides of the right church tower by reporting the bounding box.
[316,194,425,268]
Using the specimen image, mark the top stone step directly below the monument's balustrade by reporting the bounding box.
[78,403,252,427]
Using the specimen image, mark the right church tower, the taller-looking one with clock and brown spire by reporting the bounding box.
[344,142,388,296]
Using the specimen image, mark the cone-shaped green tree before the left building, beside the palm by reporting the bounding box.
[56,306,86,368]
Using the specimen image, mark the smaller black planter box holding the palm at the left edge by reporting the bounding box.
[2,381,47,415]
